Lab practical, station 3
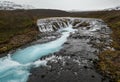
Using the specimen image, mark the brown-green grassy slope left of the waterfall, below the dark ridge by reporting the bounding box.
[0,11,37,53]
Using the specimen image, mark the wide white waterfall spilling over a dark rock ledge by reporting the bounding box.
[37,17,95,33]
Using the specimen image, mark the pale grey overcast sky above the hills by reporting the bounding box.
[0,0,120,10]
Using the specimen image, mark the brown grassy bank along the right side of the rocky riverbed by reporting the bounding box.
[70,11,120,82]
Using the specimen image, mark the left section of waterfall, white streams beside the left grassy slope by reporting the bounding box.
[37,17,71,32]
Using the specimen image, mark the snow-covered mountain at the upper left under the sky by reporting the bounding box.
[0,1,34,10]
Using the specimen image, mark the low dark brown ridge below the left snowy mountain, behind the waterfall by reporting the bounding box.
[0,9,70,18]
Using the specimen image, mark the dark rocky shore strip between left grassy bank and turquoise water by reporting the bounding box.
[0,32,61,58]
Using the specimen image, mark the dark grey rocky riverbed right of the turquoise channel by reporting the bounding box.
[28,20,112,82]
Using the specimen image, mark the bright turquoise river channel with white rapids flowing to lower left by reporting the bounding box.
[0,26,75,82]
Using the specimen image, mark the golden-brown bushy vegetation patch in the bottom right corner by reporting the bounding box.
[98,50,120,82]
